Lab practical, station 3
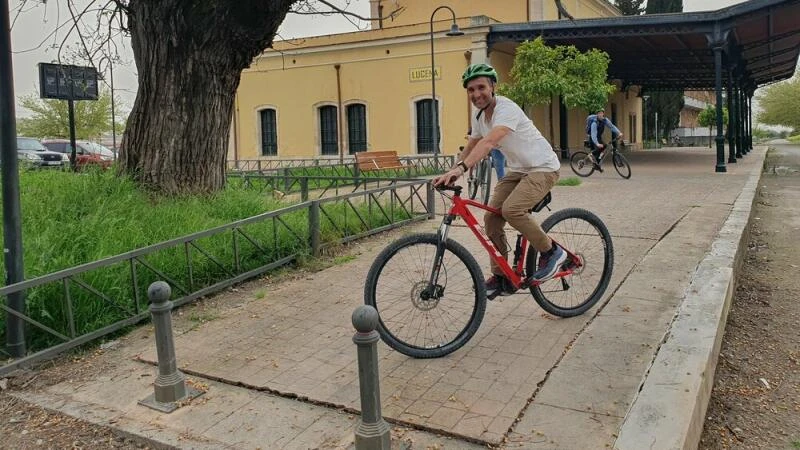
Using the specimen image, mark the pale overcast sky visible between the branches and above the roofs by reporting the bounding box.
[10,0,744,116]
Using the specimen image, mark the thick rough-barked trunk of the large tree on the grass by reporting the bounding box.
[119,0,297,194]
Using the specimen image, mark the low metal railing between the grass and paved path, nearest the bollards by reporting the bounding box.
[0,180,435,376]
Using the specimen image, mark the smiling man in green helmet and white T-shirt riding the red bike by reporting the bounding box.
[433,64,567,298]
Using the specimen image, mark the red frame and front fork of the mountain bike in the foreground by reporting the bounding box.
[430,187,583,289]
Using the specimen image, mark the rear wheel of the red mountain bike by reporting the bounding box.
[526,208,614,317]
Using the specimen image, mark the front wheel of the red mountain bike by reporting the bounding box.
[364,233,486,358]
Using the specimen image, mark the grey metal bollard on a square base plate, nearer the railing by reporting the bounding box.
[139,281,202,413]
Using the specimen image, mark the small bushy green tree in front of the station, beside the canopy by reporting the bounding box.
[498,37,616,139]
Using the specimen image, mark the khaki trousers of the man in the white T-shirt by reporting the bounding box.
[483,172,558,275]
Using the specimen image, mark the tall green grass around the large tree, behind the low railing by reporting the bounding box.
[0,171,422,352]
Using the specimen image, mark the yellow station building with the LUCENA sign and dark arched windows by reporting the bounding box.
[228,0,641,160]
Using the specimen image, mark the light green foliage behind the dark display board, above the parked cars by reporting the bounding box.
[17,90,123,139]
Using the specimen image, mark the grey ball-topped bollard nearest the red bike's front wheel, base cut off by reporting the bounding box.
[352,305,392,450]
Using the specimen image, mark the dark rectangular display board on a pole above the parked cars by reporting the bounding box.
[39,63,98,100]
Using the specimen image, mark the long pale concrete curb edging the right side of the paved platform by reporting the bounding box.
[614,152,766,450]
